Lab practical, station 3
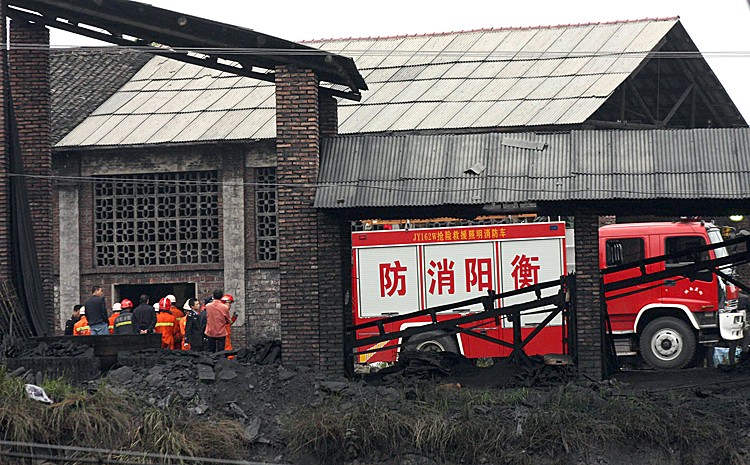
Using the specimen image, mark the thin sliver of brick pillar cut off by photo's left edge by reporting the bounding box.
[0,0,10,282]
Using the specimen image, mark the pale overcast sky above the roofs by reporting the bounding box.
[51,0,750,121]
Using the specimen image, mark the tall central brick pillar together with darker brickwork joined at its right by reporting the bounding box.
[276,66,344,372]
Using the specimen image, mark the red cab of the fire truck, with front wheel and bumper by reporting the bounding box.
[599,221,745,369]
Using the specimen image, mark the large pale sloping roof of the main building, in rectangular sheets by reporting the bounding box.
[58,19,692,147]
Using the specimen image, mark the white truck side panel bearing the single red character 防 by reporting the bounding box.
[357,245,420,317]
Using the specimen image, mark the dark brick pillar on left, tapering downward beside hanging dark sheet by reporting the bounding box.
[10,21,55,328]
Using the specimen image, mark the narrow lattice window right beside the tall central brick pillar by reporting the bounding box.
[255,168,279,262]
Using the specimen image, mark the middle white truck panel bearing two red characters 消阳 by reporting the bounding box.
[423,242,497,312]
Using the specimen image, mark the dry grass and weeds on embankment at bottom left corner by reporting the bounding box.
[0,367,248,463]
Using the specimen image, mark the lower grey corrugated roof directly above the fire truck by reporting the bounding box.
[315,128,750,208]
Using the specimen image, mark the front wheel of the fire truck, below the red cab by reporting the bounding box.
[640,317,696,370]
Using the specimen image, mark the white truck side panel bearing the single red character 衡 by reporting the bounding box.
[500,238,564,327]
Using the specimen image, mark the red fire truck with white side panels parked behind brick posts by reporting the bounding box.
[352,222,745,368]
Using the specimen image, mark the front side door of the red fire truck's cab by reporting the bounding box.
[661,235,719,312]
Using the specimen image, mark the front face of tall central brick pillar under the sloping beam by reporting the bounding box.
[276,66,321,369]
